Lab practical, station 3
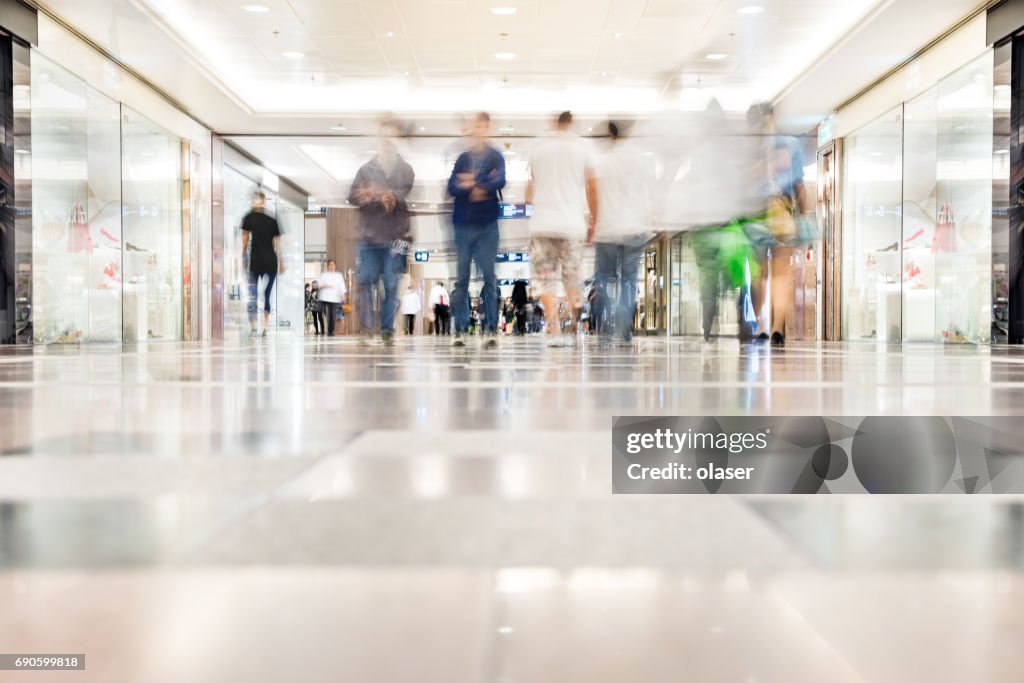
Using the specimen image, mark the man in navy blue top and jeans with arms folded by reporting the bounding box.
[449,112,505,348]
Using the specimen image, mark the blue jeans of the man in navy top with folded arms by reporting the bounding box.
[452,220,498,333]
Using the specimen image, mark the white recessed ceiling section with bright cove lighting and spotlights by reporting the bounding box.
[46,0,886,122]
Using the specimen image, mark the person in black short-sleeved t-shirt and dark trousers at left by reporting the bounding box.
[242,193,285,337]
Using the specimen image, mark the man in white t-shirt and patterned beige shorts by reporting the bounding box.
[526,112,598,346]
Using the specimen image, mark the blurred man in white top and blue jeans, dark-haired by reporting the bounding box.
[591,121,655,341]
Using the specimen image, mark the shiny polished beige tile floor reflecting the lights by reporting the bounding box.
[0,338,1024,683]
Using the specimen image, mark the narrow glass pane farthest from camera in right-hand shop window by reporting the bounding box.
[842,105,903,341]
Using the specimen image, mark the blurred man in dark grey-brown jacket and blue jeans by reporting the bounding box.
[348,121,416,346]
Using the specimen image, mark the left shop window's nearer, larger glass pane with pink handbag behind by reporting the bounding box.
[32,53,123,343]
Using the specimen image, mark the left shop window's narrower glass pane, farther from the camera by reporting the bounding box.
[121,108,182,341]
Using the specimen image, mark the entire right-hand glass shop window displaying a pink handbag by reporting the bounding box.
[843,51,993,343]
